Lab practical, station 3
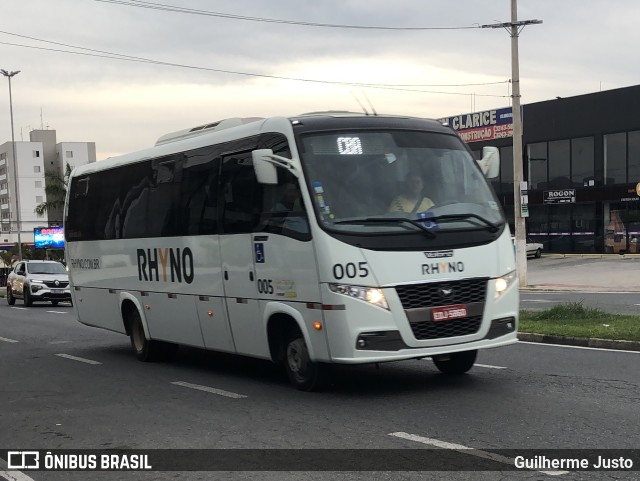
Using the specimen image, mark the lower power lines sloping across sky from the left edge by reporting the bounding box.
[0,30,509,97]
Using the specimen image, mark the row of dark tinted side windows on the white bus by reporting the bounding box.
[66,134,291,241]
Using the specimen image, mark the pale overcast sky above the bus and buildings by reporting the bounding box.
[0,0,640,160]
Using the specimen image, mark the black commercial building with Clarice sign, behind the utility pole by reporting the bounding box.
[443,85,640,253]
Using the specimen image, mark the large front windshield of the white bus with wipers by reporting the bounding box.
[300,130,504,237]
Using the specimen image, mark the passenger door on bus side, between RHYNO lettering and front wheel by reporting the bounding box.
[219,152,270,359]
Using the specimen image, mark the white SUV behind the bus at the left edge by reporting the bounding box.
[7,261,71,306]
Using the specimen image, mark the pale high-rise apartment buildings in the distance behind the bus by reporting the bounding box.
[0,130,96,247]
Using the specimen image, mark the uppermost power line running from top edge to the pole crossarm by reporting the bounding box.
[95,0,480,31]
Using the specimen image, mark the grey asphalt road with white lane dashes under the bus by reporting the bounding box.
[0,304,640,481]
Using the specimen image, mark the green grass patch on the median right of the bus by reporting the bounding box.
[518,302,640,341]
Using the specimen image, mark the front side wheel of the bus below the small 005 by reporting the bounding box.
[284,328,329,391]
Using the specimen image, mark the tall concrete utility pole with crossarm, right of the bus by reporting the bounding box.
[481,0,542,287]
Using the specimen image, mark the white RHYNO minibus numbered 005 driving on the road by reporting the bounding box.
[65,112,518,390]
